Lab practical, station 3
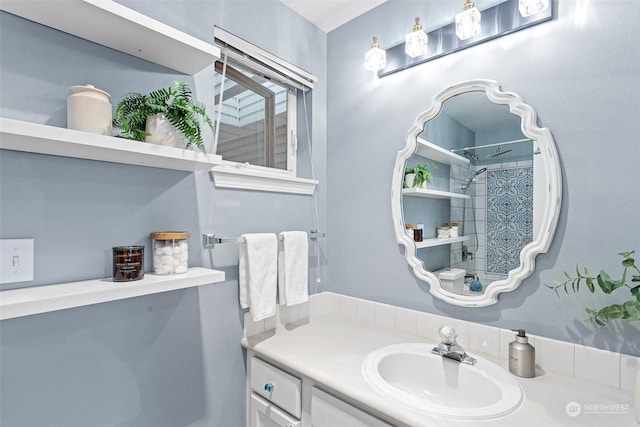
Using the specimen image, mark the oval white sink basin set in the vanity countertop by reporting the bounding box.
[362,343,524,420]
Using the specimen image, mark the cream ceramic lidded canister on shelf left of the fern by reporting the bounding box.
[67,85,112,136]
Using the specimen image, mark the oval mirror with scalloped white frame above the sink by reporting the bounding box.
[391,80,562,307]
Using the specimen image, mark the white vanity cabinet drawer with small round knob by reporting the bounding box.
[251,357,302,418]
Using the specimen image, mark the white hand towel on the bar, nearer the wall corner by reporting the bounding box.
[278,231,309,305]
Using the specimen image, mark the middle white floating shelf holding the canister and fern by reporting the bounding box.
[0,118,222,172]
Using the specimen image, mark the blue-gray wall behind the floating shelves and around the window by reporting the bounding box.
[0,0,327,427]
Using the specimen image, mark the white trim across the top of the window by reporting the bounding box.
[213,27,318,89]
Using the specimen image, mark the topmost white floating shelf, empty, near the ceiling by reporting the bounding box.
[0,0,220,75]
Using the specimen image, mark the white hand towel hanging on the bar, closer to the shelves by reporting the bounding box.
[238,233,278,321]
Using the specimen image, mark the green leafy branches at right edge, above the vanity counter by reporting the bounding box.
[545,251,640,326]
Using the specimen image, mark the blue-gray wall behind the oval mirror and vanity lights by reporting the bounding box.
[327,0,640,355]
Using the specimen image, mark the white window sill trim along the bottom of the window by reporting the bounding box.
[211,162,318,195]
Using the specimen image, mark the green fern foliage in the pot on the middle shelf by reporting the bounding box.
[113,82,213,152]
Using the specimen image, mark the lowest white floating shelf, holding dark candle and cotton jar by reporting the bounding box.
[0,267,224,320]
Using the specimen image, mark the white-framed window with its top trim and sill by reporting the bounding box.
[214,27,316,194]
